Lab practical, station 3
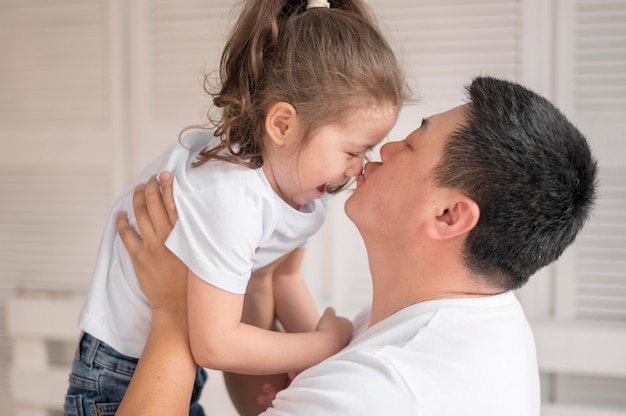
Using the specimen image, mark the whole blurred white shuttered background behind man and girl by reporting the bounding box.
[0,0,626,416]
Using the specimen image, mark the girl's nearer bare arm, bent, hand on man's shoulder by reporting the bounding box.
[187,272,352,374]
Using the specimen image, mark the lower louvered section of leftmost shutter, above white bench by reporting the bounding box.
[0,167,111,291]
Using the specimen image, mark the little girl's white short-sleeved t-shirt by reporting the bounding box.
[79,131,329,357]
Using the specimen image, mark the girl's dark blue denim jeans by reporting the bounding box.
[64,333,207,416]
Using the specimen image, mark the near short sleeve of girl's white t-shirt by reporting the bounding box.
[166,180,263,294]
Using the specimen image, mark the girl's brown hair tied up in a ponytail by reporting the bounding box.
[188,0,408,179]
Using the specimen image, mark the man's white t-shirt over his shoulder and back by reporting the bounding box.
[263,292,540,416]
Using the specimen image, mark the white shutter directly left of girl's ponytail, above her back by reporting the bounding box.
[129,0,234,172]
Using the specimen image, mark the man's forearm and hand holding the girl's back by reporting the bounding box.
[116,174,197,416]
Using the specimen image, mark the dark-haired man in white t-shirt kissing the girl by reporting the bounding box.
[114,77,597,416]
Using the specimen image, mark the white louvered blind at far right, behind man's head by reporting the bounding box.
[572,0,626,322]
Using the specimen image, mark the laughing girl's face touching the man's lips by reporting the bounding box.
[270,107,398,208]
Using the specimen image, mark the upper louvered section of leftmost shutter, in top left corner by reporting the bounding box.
[0,0,111,129]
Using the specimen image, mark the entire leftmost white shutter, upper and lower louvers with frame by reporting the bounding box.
[0,0,126,415]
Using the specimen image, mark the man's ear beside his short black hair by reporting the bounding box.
[428,194,480,240]
